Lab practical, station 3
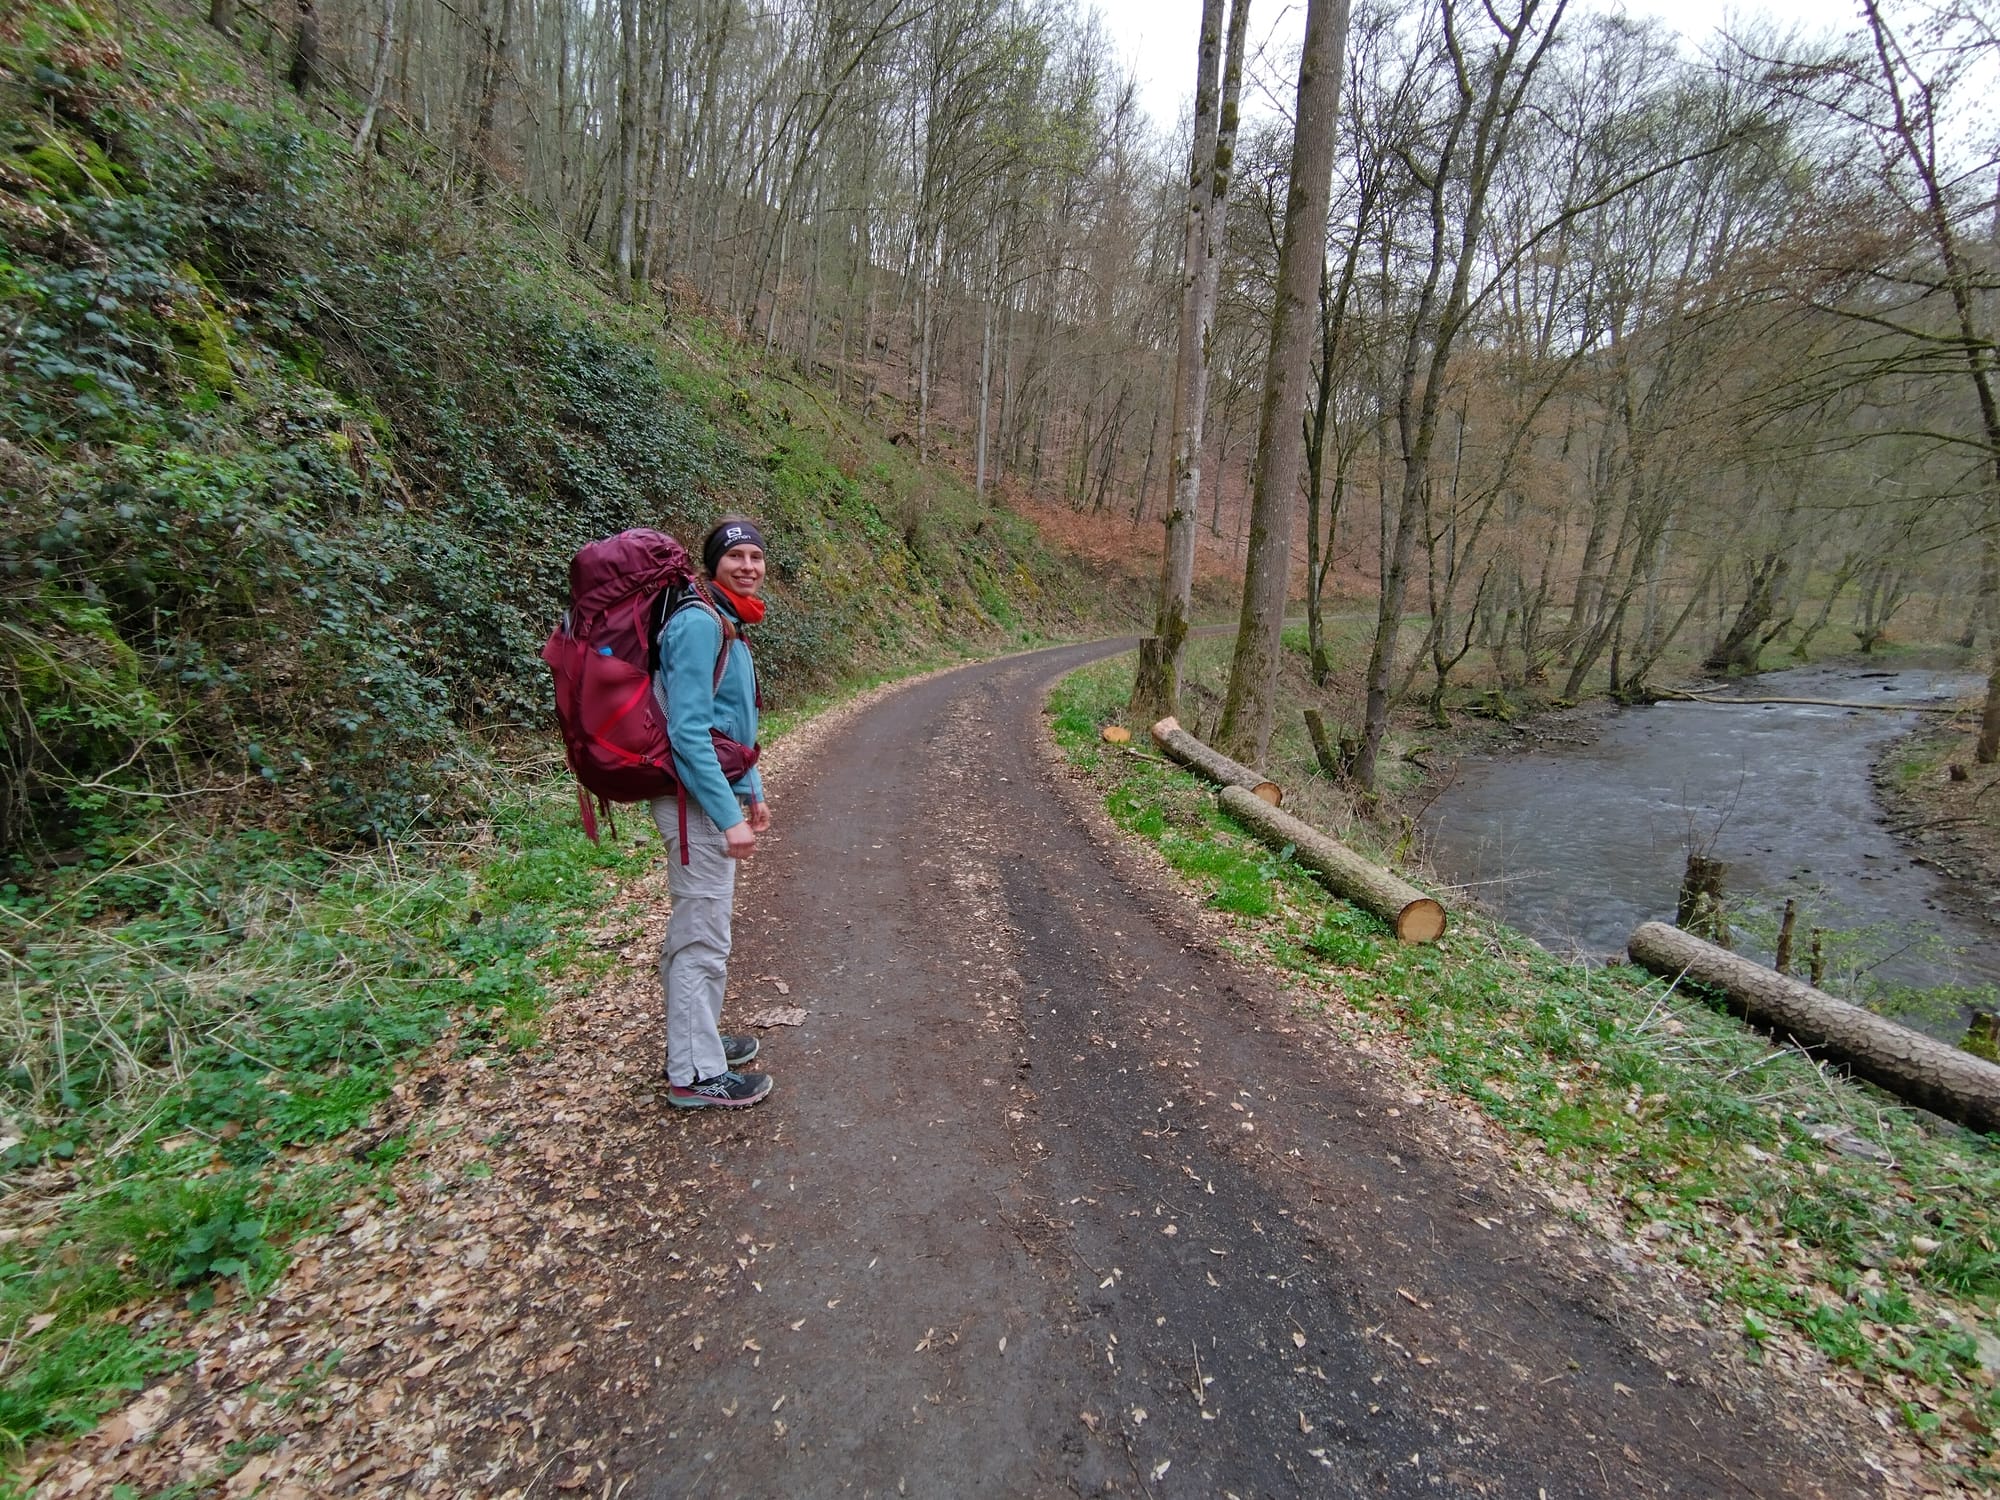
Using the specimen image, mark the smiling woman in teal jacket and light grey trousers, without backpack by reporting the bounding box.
[652,516,770,1108]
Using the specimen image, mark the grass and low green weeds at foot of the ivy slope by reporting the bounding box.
[0,768,652,1450]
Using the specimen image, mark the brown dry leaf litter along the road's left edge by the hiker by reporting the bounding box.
[16,828,806,1500]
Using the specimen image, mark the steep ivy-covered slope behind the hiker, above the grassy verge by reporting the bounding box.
[0,6,1096,846]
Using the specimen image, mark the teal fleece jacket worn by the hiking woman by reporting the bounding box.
[652,592,764,828]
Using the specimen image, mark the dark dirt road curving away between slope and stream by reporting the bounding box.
[606,642,1876,1500]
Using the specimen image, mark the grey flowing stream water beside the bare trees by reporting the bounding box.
[1424,668,2000,1032]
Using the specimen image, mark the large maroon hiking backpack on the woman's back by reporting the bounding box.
[542,528,758,860]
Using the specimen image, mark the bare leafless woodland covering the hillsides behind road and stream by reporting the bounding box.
[258,0,2000,778]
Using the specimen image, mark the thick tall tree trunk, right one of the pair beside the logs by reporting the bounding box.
[1218,0,1348,762]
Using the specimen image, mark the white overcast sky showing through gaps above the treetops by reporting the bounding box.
[1084,0,1860,130]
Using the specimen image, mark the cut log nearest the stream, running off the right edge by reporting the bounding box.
[1626,922,2000,1130]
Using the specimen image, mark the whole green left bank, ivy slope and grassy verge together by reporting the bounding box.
[0,4,1088,1450]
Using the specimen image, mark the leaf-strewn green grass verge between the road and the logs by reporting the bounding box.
[1048,660,2000,1486]
